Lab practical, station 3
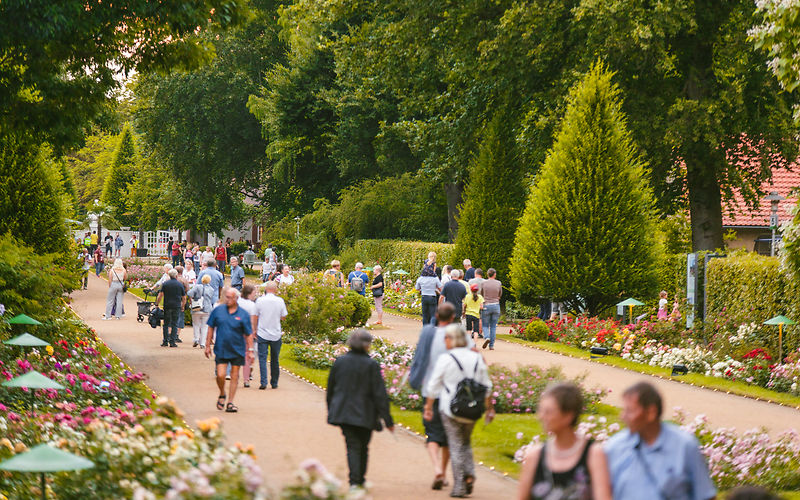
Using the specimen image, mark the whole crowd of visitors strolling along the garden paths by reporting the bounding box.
[76,243,732,500]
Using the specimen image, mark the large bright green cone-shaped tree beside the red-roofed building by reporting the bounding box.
[511,64,656,315]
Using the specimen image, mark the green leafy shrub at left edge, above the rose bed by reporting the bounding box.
[0,234,79,321]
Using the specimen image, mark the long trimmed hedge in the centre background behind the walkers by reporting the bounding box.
[339,240,454,278]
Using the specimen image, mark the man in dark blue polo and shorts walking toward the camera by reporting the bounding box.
[205,288,255,413]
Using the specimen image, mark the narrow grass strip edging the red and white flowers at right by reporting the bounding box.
[497,334,800,409]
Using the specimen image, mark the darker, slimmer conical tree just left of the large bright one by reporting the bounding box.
[455,107,527,280]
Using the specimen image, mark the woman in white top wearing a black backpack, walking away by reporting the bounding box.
[423,324,494,497]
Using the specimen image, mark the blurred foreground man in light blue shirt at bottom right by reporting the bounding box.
[605,382,717,500]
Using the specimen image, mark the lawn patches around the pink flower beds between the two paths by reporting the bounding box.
[280,344,619,478]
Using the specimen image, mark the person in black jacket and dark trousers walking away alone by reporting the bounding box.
[327,329,394,487]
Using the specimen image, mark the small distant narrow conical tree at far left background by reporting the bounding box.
[101,124,137,226]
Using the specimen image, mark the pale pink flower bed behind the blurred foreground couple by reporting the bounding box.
[514,409,800,491]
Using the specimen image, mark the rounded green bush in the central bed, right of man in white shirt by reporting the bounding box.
[278,276,369,342]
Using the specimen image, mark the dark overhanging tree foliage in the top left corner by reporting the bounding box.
[0,0,244,152]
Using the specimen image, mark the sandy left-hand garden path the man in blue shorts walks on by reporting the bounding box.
[72,275,516,500]
